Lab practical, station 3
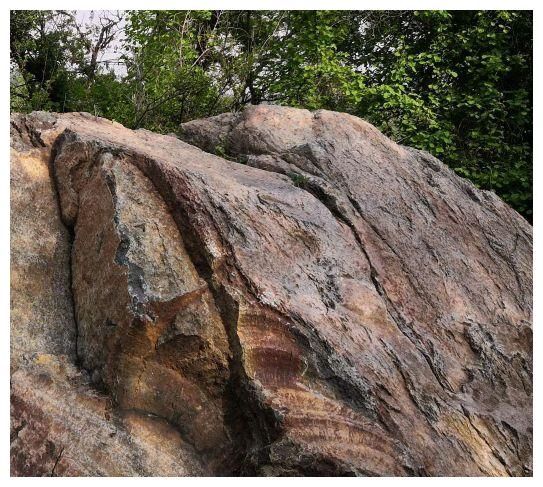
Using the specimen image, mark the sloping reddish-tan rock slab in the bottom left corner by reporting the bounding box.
[11,355,209,476]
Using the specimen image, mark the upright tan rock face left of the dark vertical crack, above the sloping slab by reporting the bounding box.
[10,113,75,370]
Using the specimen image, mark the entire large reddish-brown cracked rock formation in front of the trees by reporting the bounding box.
[11,106,532,476]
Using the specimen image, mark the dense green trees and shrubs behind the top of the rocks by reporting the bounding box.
[10,10,533,220]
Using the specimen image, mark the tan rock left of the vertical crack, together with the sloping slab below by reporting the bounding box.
[11,113,212,476]
